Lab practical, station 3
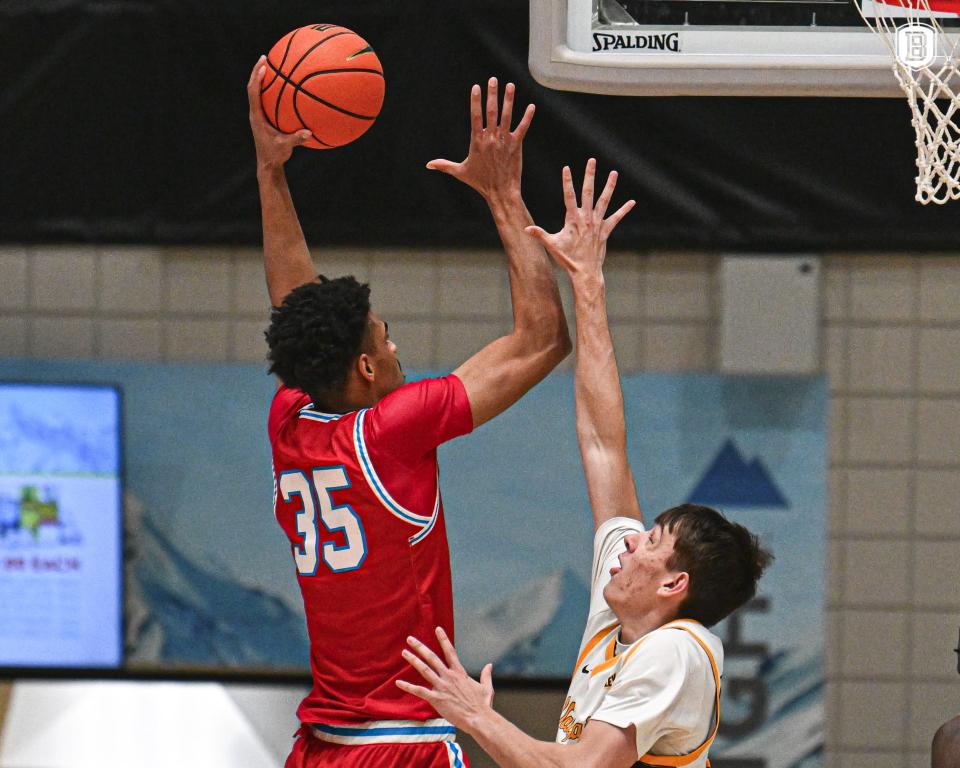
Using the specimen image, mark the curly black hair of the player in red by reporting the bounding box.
[264,275,370,402]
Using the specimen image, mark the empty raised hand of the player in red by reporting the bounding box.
[427,77,535,201]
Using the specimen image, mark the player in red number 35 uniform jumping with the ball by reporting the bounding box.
[247,59,570,768]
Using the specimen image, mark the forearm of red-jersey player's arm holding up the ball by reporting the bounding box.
[257,165,316,307]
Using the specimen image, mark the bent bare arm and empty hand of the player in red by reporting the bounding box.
[427,78,570,427]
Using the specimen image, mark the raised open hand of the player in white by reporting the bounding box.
[526,158,636,275]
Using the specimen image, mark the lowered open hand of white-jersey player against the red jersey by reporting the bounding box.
[397,627,493,732]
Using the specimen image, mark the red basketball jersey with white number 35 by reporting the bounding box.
[268,376,473,725]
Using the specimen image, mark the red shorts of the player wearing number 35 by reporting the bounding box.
[284,728,470,768]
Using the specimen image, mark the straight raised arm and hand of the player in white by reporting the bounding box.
[531,159,641,527]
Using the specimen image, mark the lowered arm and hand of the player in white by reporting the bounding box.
[397,628,637,768]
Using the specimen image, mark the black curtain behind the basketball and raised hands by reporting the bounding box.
[0,0,960,252]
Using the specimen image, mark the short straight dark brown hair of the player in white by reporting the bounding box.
[654,504,773,627]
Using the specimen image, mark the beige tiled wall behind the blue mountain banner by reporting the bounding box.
[0,246,960,768]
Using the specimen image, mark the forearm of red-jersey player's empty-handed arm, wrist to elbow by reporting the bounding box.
[488,192,570,362]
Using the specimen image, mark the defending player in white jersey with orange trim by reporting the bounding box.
[397,160,771,768]
